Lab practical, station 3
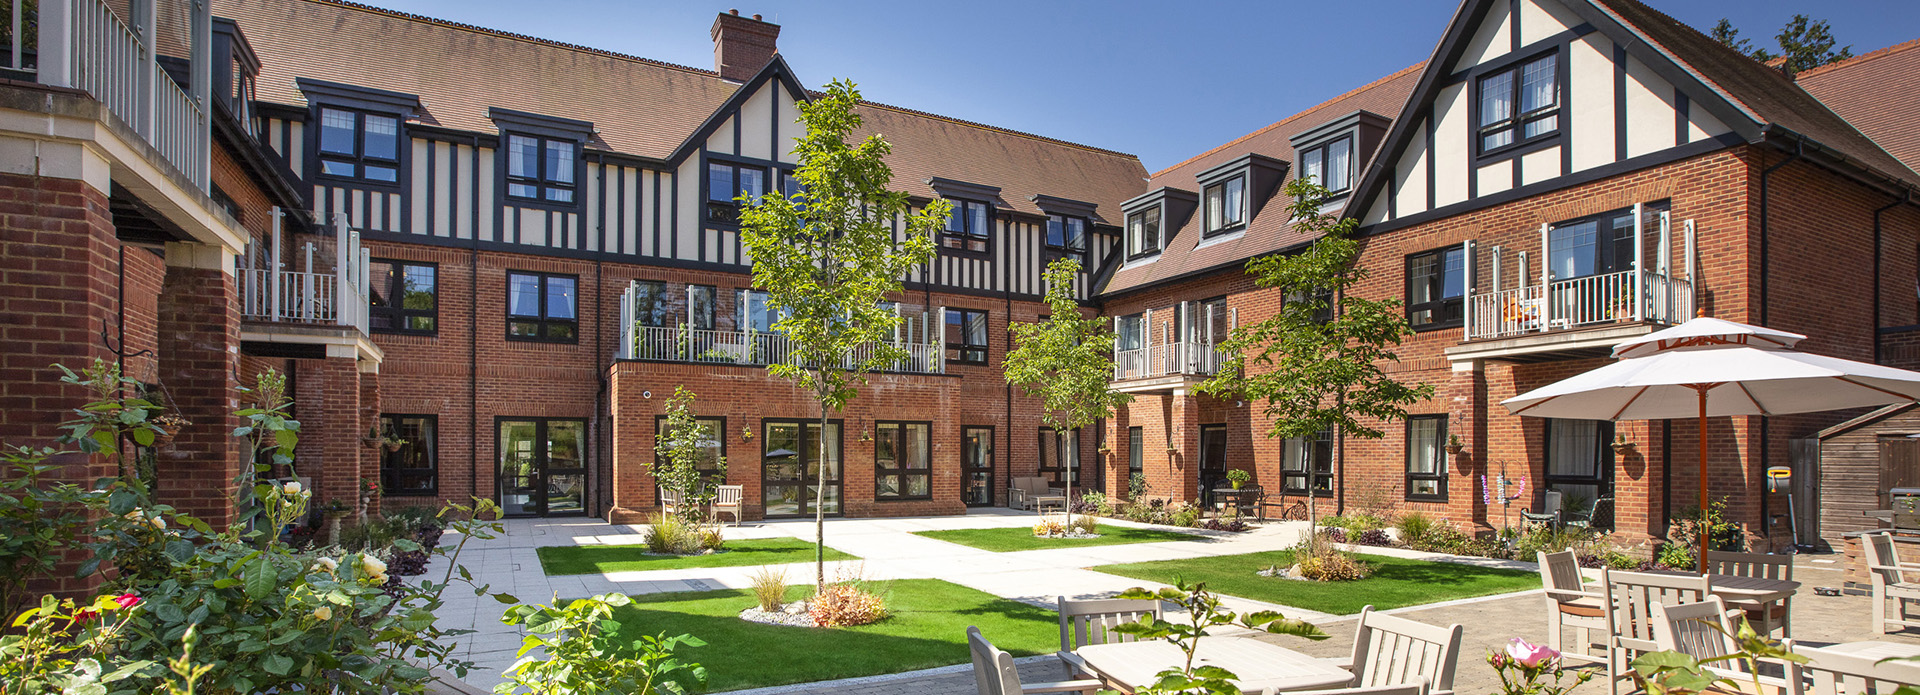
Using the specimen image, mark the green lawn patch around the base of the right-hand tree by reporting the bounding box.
[1094,551,1540,614]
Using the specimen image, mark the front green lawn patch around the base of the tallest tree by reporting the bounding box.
[614,580,1060,691]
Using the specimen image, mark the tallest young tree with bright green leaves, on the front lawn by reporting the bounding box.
[739,81,950,589]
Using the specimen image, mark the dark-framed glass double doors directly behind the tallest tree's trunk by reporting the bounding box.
[760,420,841,516]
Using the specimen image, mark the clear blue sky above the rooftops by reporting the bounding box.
[363,0,1920,171]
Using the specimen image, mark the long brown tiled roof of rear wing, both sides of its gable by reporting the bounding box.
[213,0,1146,219]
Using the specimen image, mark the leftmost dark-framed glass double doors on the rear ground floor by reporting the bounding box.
[497,419,588,516]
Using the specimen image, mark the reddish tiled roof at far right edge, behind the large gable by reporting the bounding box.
[1793,38,1920,176]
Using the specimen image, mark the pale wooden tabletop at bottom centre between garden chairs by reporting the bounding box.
[1073,635,1354,693]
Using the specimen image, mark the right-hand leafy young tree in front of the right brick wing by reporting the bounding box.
[1198,179,1434,538]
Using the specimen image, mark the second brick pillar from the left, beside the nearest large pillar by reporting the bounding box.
[156,244,250,528]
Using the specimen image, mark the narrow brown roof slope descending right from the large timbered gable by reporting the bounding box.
[1596,0,1920,186]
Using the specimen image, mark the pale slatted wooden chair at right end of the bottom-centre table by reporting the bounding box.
[1334,605,1465,695]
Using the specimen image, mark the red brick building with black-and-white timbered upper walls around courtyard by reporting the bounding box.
[11,0,1920,545]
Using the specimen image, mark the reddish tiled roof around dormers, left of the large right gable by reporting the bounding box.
[1102,63,1425,294]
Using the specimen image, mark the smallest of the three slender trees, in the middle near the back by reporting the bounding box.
[1006,257,1133,526]
